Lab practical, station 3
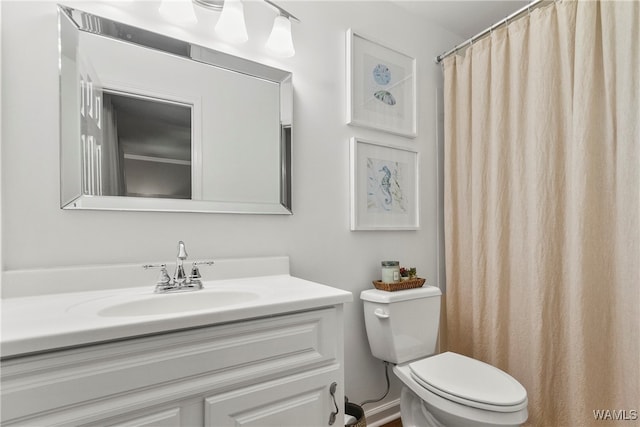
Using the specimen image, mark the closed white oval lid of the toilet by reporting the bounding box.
[409,352,527,410]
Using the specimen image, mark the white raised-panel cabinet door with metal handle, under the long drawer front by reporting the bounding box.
[205,365,342,427]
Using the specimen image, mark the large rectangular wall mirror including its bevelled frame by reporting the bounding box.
[58,6,293,214]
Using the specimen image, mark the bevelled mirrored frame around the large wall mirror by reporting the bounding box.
[58,4,293,215]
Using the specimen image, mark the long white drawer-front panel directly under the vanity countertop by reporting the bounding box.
[1,307,340,425]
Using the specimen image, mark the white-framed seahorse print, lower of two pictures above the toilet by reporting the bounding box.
[350,137,420,231]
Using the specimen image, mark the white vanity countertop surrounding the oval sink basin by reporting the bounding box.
[1,274,353,358]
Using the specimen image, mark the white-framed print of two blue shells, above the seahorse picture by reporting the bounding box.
[346,29,417,138]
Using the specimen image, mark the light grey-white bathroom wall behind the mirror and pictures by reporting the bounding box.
[1,1,459,418]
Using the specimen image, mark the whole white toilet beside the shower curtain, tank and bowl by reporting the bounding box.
[360,286,528,427]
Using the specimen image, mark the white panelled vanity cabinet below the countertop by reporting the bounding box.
[1,304,344,427]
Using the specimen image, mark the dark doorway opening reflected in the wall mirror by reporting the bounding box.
[95,92,191,199]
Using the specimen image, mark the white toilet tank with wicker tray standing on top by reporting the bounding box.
[360,286,442,363]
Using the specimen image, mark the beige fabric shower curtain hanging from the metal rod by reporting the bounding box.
[444,0,640,426]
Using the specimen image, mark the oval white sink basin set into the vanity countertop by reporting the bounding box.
[97,290,259,317]
